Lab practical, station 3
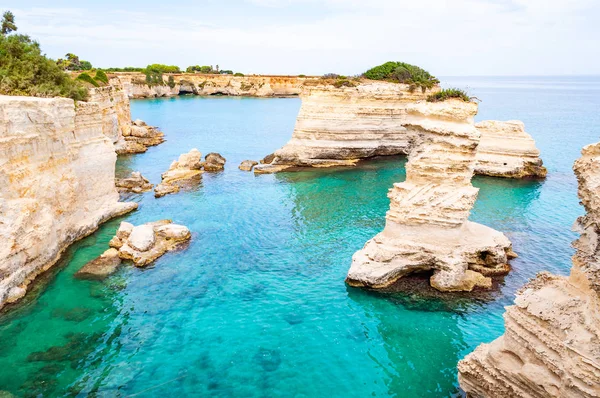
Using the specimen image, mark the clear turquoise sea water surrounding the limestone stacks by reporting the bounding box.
[0,77,600,397]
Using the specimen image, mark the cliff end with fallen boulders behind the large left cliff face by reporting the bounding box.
[89,84,164,154]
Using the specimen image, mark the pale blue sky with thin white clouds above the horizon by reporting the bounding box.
[0,0,600,76]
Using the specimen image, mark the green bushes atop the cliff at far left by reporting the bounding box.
[0,11,88,100]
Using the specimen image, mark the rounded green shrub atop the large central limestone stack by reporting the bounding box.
[363,62,440,92]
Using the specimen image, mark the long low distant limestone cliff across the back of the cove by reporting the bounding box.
[111,72,312,98]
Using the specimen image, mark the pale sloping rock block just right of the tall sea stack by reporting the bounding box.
[475,120,547,178]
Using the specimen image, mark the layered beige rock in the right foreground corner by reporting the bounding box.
[458,143,600,398]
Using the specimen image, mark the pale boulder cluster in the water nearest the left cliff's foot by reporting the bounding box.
[110,220,192,267]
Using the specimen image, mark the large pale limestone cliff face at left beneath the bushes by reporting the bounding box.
[0,96,137,307]
